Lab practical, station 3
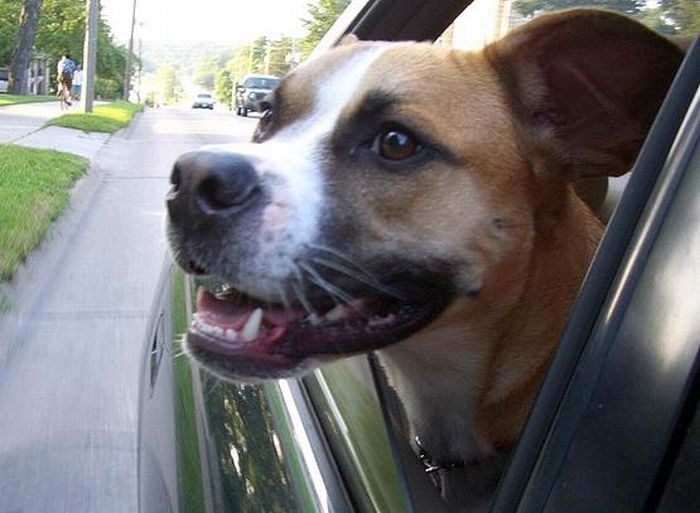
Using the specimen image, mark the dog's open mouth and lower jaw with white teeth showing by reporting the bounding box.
[187,276,453,381]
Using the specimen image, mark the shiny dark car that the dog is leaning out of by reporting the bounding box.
[139,0,700,513]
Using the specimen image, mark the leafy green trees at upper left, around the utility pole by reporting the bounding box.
[0,0,127,98]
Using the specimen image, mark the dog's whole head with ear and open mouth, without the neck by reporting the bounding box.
[167,11,681,377]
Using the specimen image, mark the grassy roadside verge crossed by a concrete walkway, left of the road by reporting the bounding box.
[0,102,143,298]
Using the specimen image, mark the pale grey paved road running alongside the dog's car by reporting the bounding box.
[0,108,256,513]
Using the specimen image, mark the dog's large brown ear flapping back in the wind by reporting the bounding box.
[486,9,683,181]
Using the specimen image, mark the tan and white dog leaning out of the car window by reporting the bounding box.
[167,9,683,511]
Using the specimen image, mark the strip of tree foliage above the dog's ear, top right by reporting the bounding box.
[514,0,700,36]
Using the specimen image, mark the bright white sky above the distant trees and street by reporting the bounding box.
[101,0,309,44]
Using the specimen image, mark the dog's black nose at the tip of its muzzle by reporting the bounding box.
[166,150,260,223]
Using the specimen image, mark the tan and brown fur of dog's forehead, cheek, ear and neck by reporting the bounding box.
[254,10,681,504]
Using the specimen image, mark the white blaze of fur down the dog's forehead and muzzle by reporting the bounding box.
[202,43,400,283]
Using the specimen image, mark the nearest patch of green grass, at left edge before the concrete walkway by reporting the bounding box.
[0,145,88,280]
